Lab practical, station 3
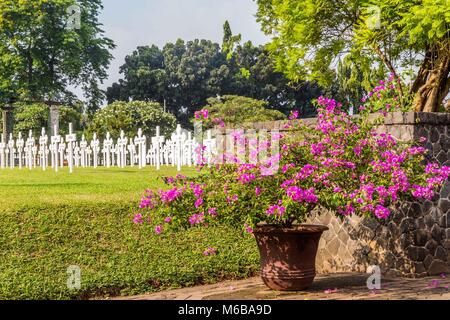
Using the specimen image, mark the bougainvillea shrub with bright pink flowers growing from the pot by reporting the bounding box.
[135,97,450,233]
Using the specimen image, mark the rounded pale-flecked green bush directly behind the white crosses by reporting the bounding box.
[88,101,176,138]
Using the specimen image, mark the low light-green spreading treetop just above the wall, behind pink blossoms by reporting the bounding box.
[203,95,286,127]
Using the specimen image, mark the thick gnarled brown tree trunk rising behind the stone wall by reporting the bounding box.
[411,46,450,112]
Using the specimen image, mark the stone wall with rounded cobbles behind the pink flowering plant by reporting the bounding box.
[219,112,450,277]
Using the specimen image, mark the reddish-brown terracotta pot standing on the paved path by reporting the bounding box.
[254,224,328,290]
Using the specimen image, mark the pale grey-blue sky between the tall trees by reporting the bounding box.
[80,0,268,95]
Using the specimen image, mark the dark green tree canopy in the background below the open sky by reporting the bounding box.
[106,22,321,125]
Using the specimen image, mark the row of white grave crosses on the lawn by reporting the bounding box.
[0,123,215,173]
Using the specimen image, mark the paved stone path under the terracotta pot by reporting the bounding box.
[117,273,450,300]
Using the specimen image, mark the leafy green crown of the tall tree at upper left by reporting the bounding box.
[0,0,114,111]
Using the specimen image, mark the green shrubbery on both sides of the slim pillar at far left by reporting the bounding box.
[14,103,82,137]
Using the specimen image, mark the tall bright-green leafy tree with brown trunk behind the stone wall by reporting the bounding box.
[256,0,450,111]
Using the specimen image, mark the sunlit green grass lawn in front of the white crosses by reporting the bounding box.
[0,168,258,299]
